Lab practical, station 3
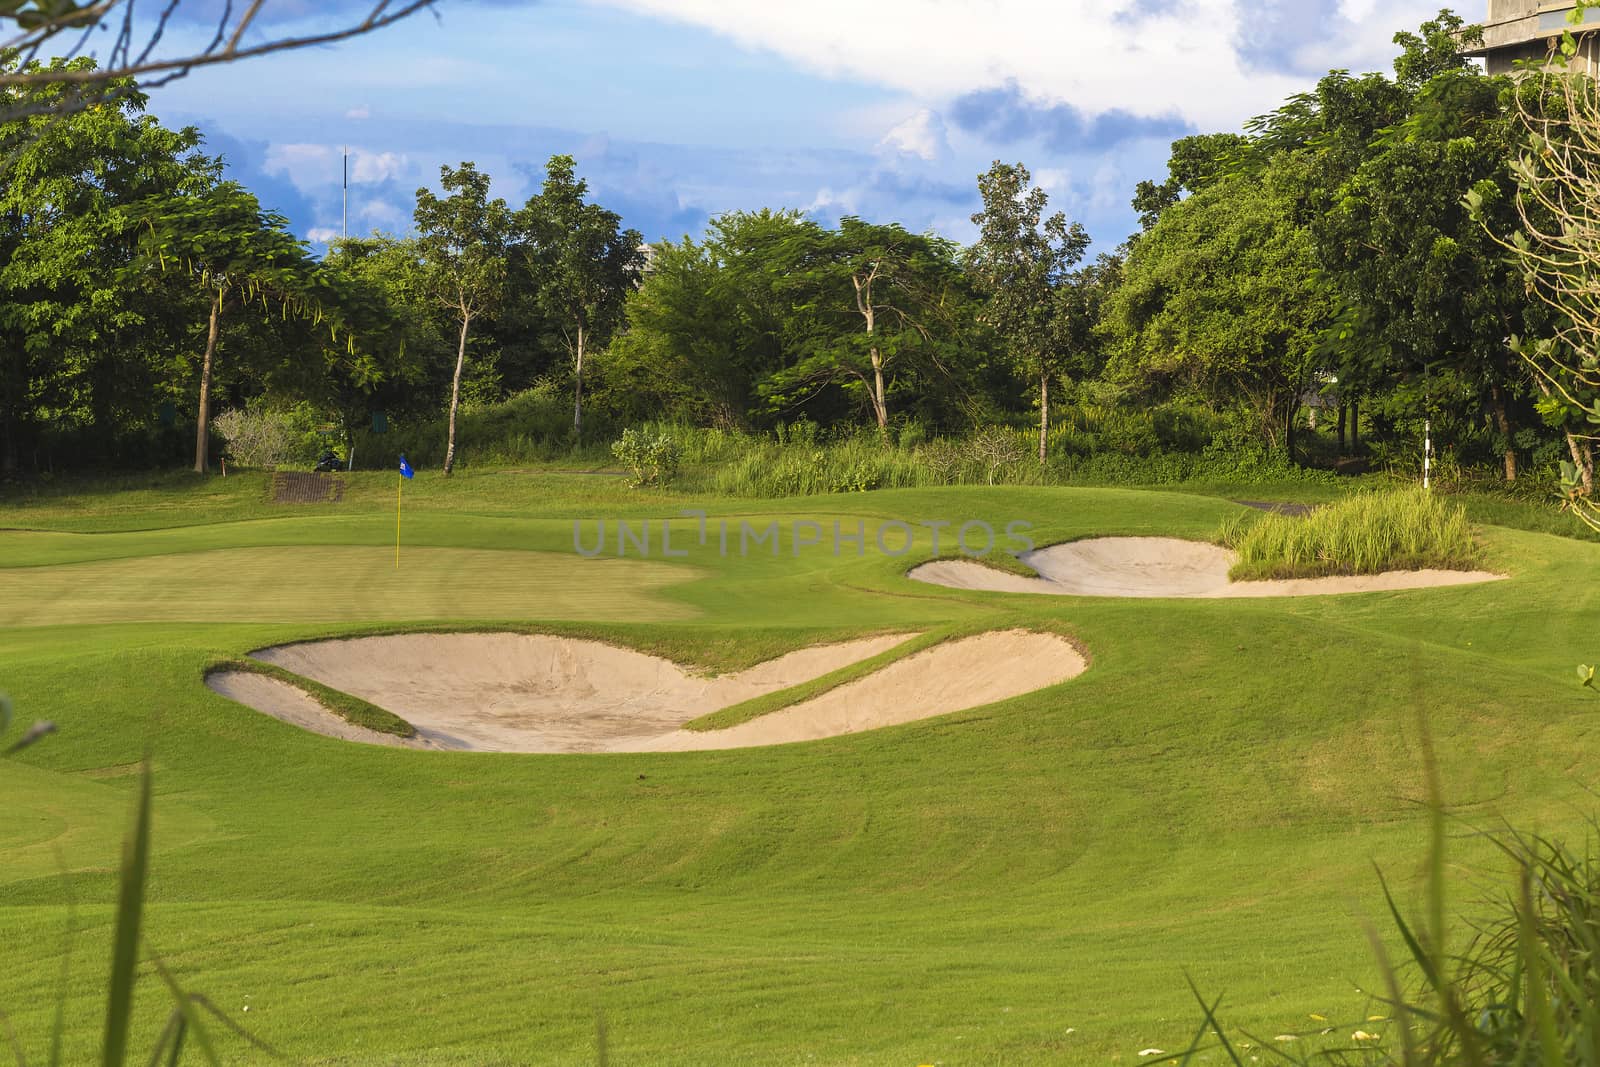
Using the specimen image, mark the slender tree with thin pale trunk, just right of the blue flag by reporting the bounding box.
[414,163,512,477]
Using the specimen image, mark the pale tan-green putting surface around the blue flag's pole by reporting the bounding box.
[0,545,696,625]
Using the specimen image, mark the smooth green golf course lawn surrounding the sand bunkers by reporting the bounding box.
[0,470,1600,1065]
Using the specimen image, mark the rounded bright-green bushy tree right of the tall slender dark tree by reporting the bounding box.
[1106,174,1331,451]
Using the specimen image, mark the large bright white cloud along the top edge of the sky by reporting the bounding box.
[590,0,1459,130]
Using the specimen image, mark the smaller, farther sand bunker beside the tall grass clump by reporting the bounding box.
[909,537,1504,597]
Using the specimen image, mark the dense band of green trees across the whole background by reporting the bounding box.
[0,11,1592,505]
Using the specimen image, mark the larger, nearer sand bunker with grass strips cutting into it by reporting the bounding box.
[206,630,1086,752]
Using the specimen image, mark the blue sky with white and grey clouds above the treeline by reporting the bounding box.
[152,0,1483,248]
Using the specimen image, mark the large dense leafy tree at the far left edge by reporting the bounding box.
[0,59,216,472]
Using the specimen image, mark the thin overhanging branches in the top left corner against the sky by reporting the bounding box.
[0,0,434,118]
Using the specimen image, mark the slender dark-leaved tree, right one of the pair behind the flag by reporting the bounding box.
[517,155,645,438]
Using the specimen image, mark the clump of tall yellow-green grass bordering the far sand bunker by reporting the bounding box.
[1218,488,1480,579]
